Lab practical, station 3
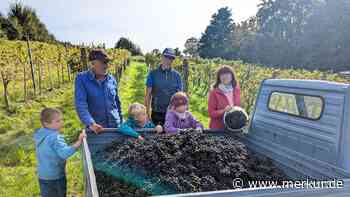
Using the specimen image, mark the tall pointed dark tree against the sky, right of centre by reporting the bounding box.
[199,7,237,59]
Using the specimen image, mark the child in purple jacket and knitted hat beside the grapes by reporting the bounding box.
[164,92,203,133]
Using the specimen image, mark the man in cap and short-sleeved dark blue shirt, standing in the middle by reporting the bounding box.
[145,48,183,125]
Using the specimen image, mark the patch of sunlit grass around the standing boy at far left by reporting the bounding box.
[0,83,83,197]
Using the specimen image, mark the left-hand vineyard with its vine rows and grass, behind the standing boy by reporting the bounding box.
[0,39,130,196]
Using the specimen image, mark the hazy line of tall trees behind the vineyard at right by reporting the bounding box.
[184,0,350,71]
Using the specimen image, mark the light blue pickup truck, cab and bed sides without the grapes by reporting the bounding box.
[83,79,350,197]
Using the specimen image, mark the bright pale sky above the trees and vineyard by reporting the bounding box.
[0,0,260,52]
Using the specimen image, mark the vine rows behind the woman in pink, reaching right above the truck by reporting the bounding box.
[142,54,350,125]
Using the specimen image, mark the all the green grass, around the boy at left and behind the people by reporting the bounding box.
[0,62,208,197]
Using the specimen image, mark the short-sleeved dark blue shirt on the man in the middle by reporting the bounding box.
[146,66,183,113]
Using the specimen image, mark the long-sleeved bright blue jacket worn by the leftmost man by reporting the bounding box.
[75,70,123,128]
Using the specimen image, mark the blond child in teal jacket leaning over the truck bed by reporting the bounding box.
[119,103,163,140]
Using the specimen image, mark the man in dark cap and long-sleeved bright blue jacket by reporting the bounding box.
[75,49,123,134]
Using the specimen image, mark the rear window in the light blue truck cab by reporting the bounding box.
[268,92,324,120]
